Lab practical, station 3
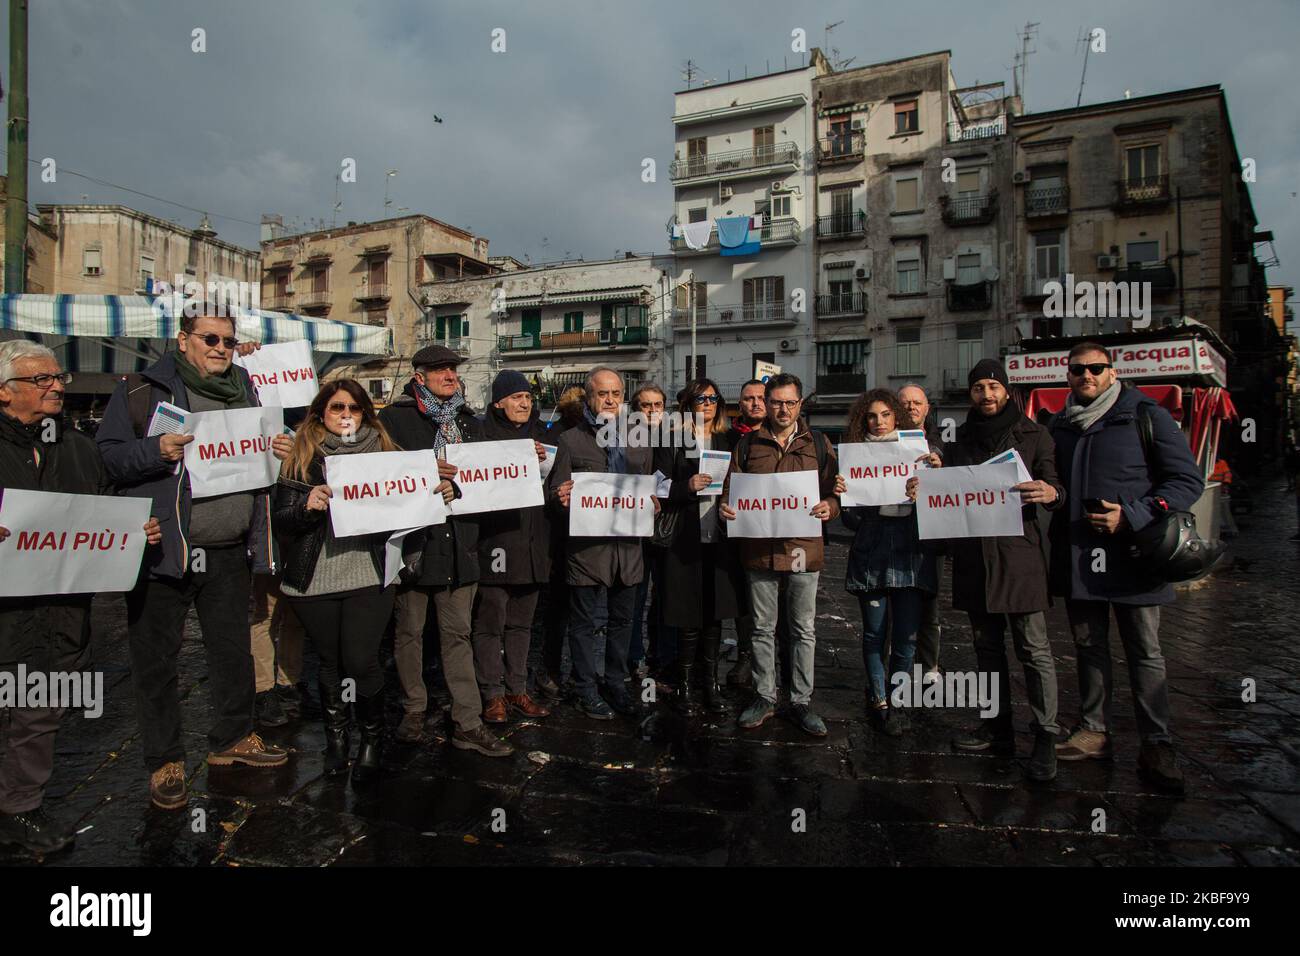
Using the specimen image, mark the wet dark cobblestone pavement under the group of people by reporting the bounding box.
[0,480,1300,866]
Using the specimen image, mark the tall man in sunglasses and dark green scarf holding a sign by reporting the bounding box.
[95,302,291,810]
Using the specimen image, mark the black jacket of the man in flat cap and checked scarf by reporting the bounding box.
[380,382,482,588]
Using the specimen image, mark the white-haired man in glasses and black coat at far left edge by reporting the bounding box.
[0,339,163,853]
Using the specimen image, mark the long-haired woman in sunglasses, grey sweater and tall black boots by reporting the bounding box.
[272,378,399,786]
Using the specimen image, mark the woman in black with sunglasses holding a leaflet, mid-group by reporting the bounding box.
[657,378,746,717]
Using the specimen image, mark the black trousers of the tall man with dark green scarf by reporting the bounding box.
[126,545,255,774]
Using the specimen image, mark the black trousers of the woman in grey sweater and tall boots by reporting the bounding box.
[285,584,397,698]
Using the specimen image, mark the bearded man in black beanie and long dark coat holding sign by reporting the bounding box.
[915,359,1065,782]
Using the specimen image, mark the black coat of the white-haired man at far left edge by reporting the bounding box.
[0,411,108,671]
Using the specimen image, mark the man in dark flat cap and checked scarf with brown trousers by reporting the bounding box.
[380,345,515,757]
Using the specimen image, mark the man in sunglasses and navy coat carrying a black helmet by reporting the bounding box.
[1048,342,1205,795]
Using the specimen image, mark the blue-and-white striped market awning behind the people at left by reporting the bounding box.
[0,295,393,375]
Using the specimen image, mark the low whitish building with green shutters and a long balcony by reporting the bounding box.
[419,254,672,408]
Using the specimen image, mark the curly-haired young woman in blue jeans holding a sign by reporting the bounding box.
[836,389,939,737]
